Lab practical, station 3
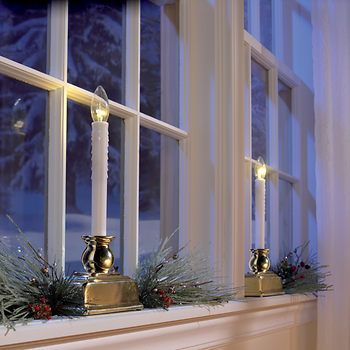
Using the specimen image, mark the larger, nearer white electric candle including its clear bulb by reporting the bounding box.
[91,86,109,236]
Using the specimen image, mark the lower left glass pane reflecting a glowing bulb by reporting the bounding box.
[0,76,47,249]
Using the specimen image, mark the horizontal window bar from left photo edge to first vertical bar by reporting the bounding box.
[0,56,65,91]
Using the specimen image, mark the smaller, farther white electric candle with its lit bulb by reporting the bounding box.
[255,157,266,248]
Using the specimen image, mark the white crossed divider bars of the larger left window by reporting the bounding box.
[0,1,188,275]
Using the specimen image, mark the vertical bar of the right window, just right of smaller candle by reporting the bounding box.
[267,68,279,259]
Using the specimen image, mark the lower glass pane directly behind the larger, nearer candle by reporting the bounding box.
[66,101,123,272]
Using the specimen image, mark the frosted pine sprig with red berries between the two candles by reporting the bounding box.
[135,238,238,309]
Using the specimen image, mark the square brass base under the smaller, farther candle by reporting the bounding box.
[245,271,284,297]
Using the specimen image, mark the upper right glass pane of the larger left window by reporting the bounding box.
[140,0,179,126]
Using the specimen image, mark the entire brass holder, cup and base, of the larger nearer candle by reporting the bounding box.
[75,236,143,315]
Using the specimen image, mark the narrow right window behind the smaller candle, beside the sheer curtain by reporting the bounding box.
[244,0,312,260]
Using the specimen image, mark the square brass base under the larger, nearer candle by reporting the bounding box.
[76,273,143,315]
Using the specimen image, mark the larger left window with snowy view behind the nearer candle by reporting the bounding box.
[0,0,183,274]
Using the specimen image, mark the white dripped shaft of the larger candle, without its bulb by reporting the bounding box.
[91,122,108,236]
